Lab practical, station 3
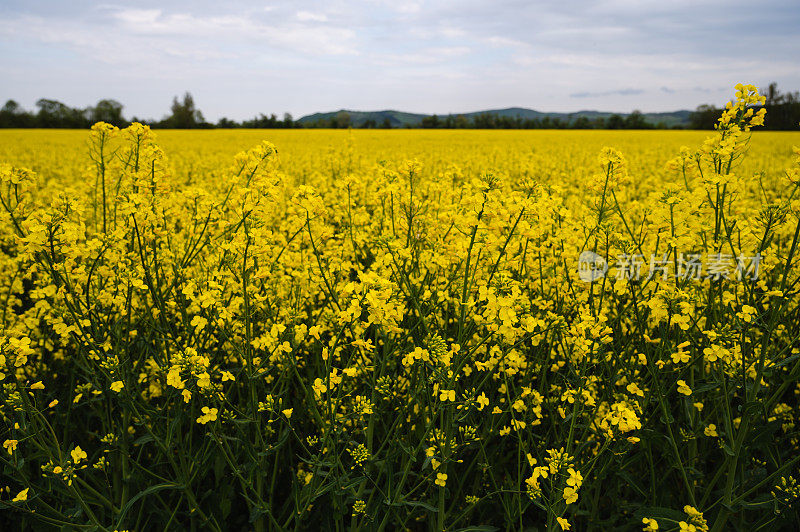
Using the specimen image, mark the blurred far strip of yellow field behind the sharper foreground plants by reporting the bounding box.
[0,129,800,194]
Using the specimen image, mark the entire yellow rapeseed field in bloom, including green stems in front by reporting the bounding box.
[0,86,800,531]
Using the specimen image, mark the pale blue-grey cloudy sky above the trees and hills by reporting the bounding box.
[0,0,800,120]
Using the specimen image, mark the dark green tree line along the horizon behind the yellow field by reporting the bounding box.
[0,83,800,130]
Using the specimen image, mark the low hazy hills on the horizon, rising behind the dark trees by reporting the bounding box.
[298,107,691,127]
